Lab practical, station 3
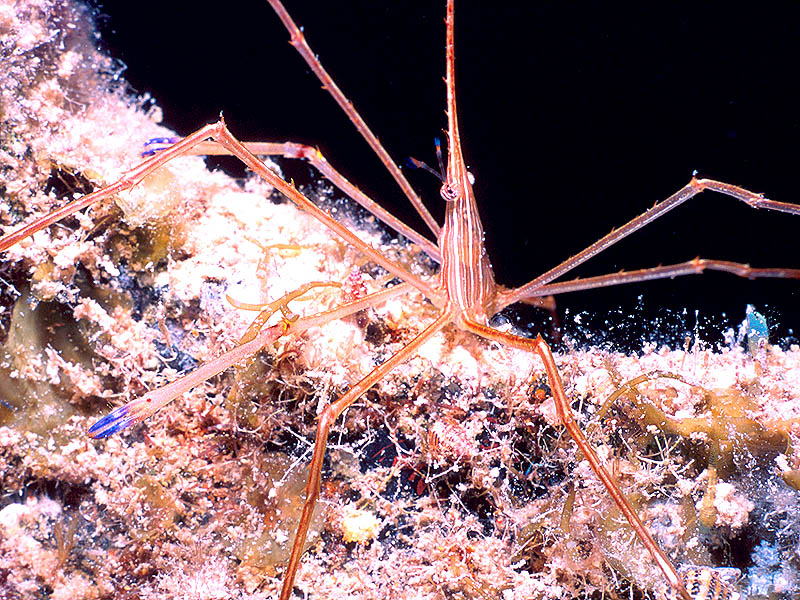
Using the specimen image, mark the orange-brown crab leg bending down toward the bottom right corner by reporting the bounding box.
[461,319,691,600]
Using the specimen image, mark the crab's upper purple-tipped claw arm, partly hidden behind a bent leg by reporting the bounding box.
[147,138,440,262]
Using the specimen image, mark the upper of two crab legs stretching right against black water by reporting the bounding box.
[499,178,800,306]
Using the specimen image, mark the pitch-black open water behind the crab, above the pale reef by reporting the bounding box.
[87,0,800,346]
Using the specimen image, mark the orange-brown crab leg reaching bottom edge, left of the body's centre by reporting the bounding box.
[280,308,453,600]
